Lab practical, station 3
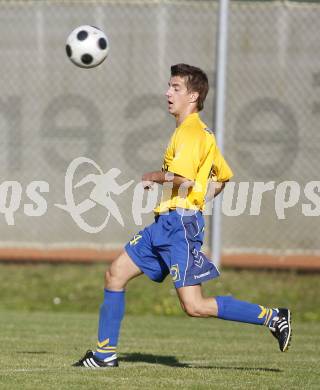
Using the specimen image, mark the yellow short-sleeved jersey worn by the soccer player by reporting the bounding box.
[154,113,233,213]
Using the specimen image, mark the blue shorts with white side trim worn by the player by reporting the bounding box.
[125,209,220,288]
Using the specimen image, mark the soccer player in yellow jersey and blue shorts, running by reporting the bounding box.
[74,64,291,368]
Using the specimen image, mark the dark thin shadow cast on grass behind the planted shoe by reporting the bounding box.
[120,353,282,372]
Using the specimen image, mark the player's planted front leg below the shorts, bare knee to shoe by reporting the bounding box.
[75,251,142,368]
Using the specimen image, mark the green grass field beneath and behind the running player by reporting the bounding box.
[0,265,320,390]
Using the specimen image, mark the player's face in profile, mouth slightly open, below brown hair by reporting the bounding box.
[166,76,190,116]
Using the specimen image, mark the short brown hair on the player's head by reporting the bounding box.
[171,64,209,111]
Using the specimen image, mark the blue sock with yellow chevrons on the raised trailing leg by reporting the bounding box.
[215,296,277,326]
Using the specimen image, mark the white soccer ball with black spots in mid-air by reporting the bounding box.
[66,26,109,68]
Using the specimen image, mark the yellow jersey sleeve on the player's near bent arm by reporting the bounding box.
[168,129,203,180]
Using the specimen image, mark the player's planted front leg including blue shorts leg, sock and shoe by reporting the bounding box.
[75,219,169,368]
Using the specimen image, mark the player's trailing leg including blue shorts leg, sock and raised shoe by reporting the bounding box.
[170,212,291,351]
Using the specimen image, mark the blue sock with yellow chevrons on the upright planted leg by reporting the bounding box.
[94,289,125,360]
